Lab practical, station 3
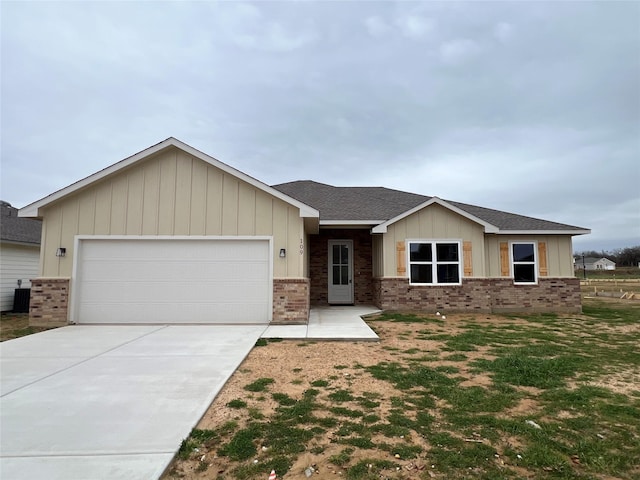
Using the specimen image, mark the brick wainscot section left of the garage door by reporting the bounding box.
[29,278,69,327]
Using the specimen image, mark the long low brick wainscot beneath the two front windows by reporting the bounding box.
[373,278,582,313]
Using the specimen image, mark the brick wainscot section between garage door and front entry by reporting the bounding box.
[271,278,309,324]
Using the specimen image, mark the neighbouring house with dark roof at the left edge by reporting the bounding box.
[0,201,42,312]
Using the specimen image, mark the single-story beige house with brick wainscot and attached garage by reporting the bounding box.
[20,138,590,325]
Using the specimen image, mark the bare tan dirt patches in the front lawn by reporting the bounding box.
[166,315,533,480]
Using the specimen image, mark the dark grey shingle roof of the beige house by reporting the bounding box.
[273,180,586,231]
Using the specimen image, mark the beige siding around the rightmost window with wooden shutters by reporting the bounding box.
[485,235,575,277]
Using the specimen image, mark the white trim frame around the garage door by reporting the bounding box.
[69,235,273,324]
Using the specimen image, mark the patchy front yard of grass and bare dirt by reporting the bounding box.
[165,299,640,480]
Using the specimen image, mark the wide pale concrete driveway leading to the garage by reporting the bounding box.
[0,325,266,480]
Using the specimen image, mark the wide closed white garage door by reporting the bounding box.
[72,238,272,323]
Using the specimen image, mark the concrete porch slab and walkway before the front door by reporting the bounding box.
[262,305,380,342]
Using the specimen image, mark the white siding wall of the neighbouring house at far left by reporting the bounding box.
[0,243,40,312]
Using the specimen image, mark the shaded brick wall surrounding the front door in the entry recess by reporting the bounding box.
[309,229,373,305]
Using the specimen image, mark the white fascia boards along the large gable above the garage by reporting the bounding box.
[18,137,320,218]
